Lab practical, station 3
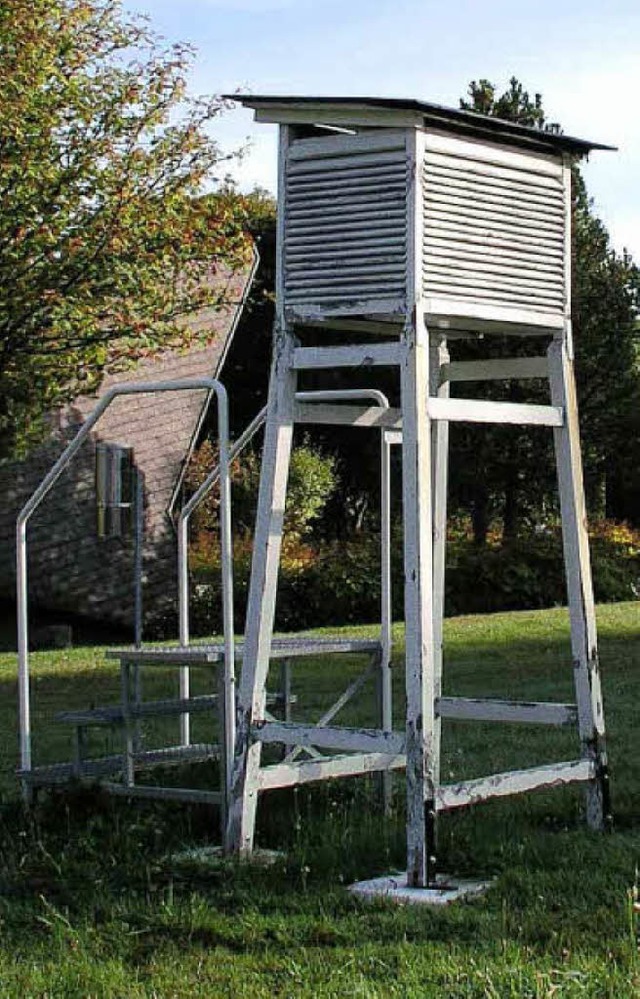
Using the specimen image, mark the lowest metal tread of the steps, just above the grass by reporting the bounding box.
[17,743,220,784]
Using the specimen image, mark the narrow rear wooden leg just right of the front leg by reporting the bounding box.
[429,337,449,786]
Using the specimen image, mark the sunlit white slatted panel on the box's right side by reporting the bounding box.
[423,135,566,322]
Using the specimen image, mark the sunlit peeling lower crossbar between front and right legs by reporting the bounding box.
[437,760,595,811]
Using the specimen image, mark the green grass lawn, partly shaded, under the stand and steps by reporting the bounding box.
[0,603,640,999]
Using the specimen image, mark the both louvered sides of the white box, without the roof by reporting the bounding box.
[283,129,570,330]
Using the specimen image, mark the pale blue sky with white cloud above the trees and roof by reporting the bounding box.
[123,0,640,262]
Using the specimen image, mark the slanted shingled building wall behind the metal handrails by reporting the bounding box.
[0,271,250,631]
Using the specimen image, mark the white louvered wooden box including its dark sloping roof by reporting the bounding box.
[230,96,607,333]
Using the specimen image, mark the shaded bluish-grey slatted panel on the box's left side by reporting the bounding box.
[284,129,407,313]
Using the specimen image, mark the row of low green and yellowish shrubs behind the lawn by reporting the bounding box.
[192,519,640,631]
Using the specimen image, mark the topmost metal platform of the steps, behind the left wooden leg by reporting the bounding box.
[106,635,381,666]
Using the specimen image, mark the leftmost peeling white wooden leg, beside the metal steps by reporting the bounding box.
[226,325,296,854]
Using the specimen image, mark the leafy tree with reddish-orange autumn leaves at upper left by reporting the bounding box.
[0,0,248,457]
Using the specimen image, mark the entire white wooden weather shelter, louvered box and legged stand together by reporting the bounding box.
[227,107,609,890]
